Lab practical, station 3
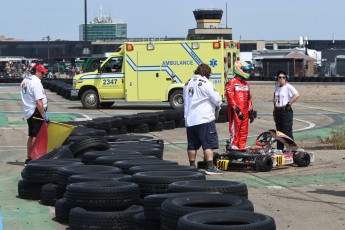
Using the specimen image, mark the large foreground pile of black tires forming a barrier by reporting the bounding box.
[18,132,275,230]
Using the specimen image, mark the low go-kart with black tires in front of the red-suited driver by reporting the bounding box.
[198,129,314,172]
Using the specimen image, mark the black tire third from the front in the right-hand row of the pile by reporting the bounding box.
[168,180,248,199]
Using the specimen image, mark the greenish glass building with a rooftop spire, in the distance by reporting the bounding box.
[79,7,127,41]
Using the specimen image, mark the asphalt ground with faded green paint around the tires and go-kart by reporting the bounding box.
[0,84,345,230]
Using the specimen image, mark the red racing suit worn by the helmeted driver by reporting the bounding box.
[225,75,253,149]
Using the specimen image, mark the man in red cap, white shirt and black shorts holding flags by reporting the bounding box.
[20,64,49,164]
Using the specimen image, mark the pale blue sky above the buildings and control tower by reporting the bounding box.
[0,0,345,41]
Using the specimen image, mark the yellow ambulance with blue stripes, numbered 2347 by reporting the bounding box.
[71,39,240,109]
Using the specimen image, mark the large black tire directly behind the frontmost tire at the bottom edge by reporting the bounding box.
[161,194,254,229]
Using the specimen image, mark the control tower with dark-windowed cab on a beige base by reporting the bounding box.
[187,9,232,40]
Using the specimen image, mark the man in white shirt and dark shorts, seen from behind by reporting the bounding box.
[183,64,224,175]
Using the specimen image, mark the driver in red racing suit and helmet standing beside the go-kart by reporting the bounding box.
[225,61,254,149]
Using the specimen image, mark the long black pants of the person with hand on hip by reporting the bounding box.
[274,109,293,150]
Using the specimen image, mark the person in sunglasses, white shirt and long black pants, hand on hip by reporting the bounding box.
[273,70,299,150]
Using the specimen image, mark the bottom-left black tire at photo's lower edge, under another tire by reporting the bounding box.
[69,205,143,230]
